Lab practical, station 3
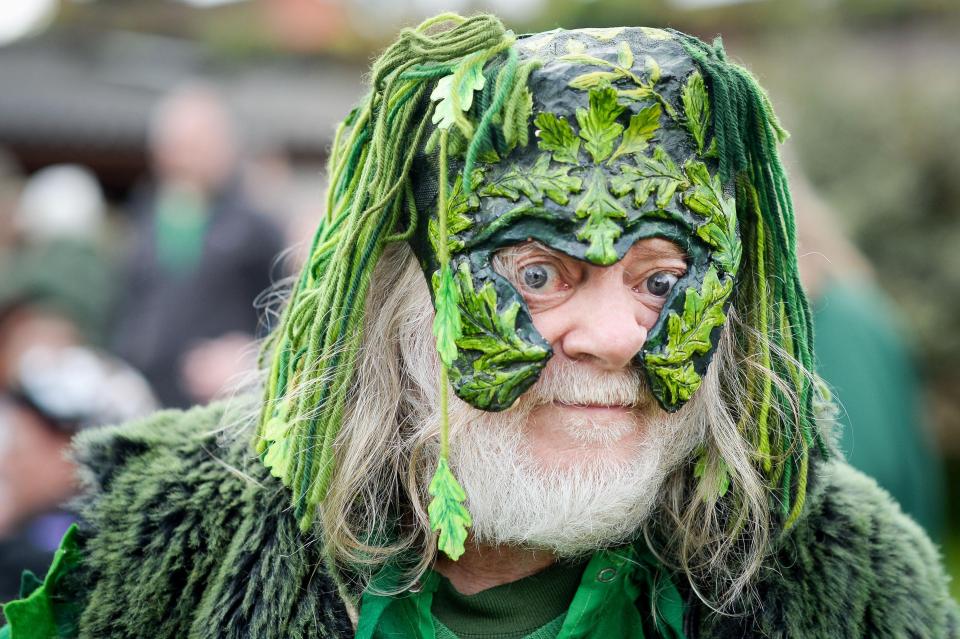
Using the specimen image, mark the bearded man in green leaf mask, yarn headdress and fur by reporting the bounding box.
[6,15,958,639]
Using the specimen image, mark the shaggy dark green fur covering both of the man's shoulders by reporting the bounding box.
[63,405,960,639]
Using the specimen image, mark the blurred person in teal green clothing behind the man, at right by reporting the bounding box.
[790,158,946,541]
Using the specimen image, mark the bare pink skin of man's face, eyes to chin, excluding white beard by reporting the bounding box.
[495,238,687,469]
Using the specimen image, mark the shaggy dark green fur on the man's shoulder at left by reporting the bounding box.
[13,404,353,639]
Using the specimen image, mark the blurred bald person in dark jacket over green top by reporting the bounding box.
[112,86,283,407]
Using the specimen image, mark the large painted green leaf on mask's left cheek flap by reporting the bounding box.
[450,262,547,408]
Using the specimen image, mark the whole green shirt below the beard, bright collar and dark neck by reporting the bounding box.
[356,546,684,639]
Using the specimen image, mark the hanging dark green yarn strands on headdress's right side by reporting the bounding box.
[673,32,828,528]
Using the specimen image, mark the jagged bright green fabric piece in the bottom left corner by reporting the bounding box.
[0,524,81,639]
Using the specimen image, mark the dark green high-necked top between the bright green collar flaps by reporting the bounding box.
[431,561,586,639]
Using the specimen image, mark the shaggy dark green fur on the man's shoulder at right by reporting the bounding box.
[696,459,960,639]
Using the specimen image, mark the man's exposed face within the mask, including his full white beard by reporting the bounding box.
[428,238,702,556]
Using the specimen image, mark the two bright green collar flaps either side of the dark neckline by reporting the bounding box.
[357,546,684,639]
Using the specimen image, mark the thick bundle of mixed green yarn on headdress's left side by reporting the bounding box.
[256,14,513,529]
